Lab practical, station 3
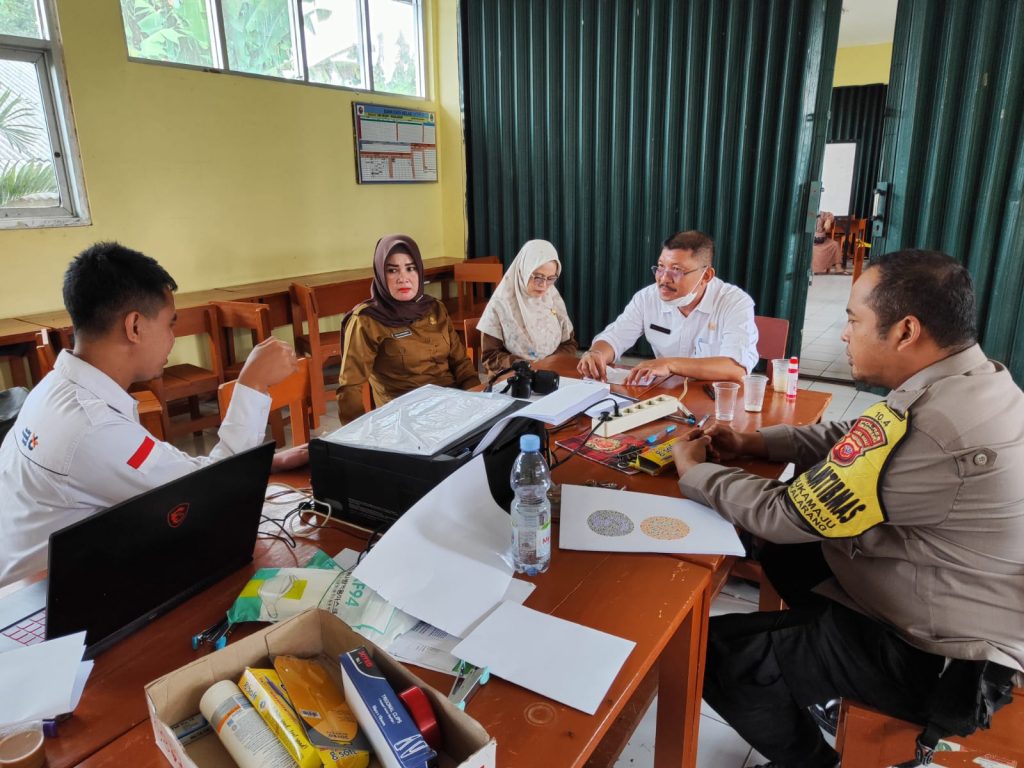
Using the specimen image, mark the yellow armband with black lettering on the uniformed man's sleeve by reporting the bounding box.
[786,401,909,539]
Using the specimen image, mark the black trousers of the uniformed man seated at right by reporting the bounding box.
[703,544,945,768]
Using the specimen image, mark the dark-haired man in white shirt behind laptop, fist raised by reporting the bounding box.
[0,243,307,586]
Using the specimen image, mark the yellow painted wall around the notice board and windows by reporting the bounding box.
[0,0,466,316]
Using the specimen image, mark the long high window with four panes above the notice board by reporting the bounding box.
[121,0,425,96]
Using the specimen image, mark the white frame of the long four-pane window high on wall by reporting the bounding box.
[120,0,430,101]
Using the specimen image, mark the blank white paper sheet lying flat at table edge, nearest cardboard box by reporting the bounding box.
[452,602,636,715]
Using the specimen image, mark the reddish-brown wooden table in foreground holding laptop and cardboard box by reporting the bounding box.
[41,489,711,768]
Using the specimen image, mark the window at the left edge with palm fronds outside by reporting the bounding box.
[0,0,87,227]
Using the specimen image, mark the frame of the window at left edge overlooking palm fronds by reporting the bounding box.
[0,0,92,229]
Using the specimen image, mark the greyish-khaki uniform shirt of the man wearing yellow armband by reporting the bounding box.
[679,345,1024,671]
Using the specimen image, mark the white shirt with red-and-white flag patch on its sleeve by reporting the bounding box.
[0,350,270,586]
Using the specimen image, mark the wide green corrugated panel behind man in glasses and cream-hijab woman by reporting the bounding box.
[461,0,840,354]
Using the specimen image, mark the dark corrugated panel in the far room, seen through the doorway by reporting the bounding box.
[828,84,886,218]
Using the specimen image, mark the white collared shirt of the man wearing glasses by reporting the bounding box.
[594,278,758,373]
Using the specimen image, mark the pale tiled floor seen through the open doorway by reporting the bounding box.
[800,274,853,381]
